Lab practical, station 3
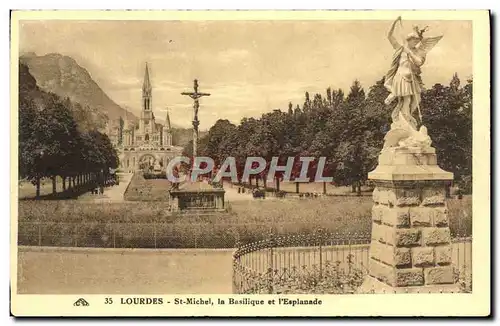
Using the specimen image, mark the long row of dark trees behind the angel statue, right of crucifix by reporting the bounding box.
[185,74,472,191]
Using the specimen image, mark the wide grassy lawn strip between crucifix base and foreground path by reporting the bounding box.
[19,196,472,248]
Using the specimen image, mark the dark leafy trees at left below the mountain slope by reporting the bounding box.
[19,64,119,197]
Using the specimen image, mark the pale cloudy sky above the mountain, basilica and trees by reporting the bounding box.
[19,20,473,130]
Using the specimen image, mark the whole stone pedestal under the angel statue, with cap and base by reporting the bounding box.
[358,147,458,293]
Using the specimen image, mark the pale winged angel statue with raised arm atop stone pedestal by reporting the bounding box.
[384,16,443,147]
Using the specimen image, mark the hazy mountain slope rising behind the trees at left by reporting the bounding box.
[19,52,137,126]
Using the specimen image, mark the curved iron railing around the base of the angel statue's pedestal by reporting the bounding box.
[233,232,472,294]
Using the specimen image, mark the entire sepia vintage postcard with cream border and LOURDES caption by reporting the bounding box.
[10,11,491,317]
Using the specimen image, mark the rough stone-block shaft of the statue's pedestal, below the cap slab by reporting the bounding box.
[370,181,453,287]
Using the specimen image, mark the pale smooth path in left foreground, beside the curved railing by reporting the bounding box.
[17,247,233,294]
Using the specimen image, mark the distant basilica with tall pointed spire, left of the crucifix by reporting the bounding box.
[106,63,182,172]
